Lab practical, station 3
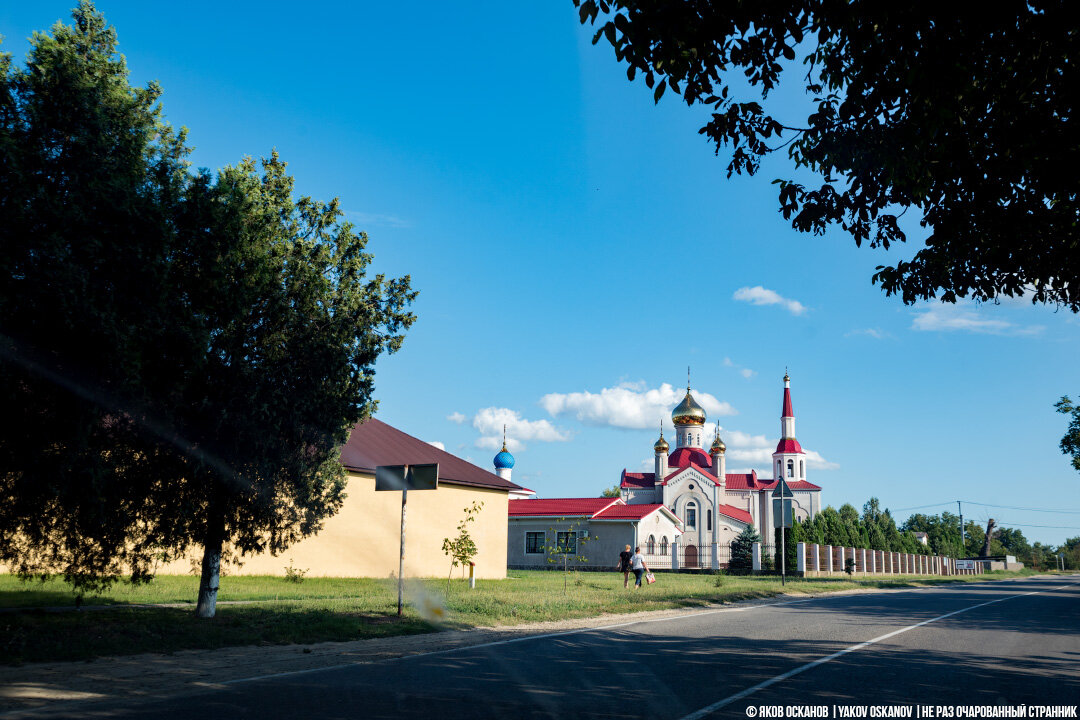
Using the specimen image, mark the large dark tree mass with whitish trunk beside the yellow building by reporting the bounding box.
[0,0,415,616]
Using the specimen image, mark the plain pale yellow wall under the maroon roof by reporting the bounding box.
[158,473,509,578]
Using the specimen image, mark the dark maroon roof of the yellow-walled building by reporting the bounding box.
[341,418,521,491]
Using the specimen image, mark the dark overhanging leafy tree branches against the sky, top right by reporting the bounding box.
[575,0,1080,312]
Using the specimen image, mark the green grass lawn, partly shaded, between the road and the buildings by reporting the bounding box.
[0,571,1032,664]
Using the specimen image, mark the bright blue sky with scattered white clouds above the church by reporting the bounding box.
[0,0,1080,543]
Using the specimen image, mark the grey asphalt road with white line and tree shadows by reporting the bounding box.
[21,576,1080,720]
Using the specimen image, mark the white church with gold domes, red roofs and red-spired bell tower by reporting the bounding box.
[619,373,821,567]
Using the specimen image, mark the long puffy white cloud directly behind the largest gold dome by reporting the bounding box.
[540,382,737,429]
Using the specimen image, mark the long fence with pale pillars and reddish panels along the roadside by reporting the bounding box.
[753,543,989,578]
